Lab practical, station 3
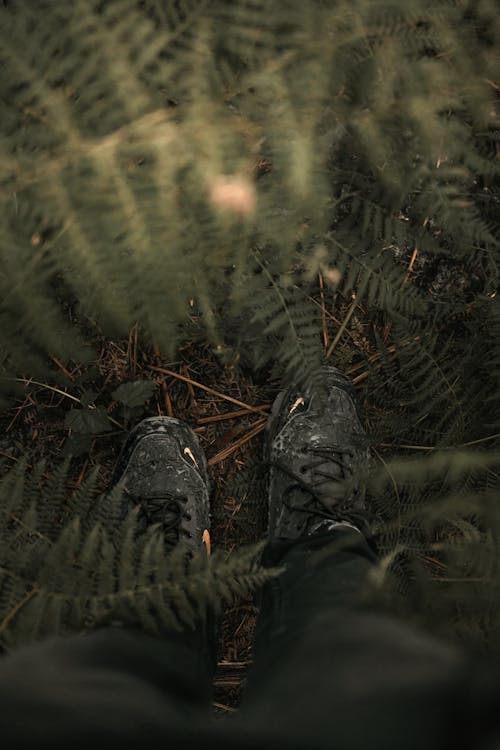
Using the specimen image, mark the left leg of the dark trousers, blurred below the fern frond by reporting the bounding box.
[0,628,213,747]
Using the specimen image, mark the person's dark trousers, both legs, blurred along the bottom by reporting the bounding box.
[0,530,500,750]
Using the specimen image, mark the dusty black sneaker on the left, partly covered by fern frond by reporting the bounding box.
[112,417,210,553]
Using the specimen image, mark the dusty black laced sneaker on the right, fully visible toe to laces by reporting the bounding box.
[265,367,369,540]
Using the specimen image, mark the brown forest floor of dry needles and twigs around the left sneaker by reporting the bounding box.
[0,284,376,715]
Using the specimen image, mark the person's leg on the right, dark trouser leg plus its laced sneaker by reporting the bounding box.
[236,373,500,750]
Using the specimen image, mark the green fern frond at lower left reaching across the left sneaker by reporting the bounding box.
[0,463,279,648]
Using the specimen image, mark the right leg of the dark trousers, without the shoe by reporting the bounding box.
[241,528,500,750]
